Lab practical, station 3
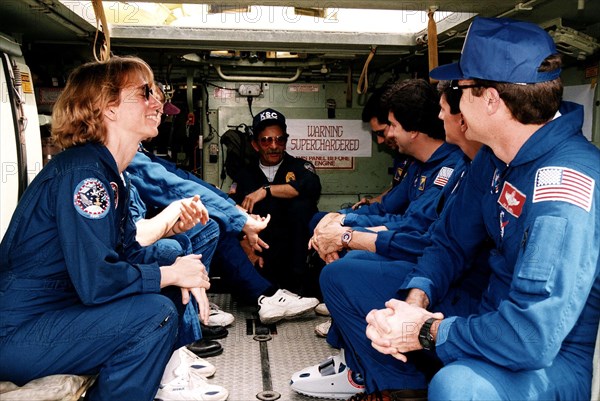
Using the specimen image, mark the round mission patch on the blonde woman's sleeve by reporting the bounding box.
[73,178,110,219]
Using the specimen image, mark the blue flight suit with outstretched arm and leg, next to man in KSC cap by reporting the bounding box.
[126,148,277,302]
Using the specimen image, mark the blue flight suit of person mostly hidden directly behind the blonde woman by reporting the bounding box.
[125,182,219,348]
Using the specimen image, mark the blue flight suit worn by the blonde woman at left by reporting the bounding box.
[0,143,178,400]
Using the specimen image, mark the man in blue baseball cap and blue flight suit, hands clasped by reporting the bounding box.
[296,18,600,401]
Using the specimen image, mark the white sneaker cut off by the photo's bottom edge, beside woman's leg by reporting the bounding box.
[154,377,229,401]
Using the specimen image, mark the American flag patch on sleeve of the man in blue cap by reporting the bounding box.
[532,167,595,212]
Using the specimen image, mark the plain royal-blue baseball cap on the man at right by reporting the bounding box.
[430,17,560,84]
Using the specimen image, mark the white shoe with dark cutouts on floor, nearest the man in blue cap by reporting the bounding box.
[290,349,365,400]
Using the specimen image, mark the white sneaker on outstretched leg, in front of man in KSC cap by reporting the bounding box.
[258,290,319,324]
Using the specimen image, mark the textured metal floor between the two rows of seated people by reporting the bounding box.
[206,294,338,401]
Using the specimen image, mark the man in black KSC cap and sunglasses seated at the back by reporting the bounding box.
[233,109,321,310]
